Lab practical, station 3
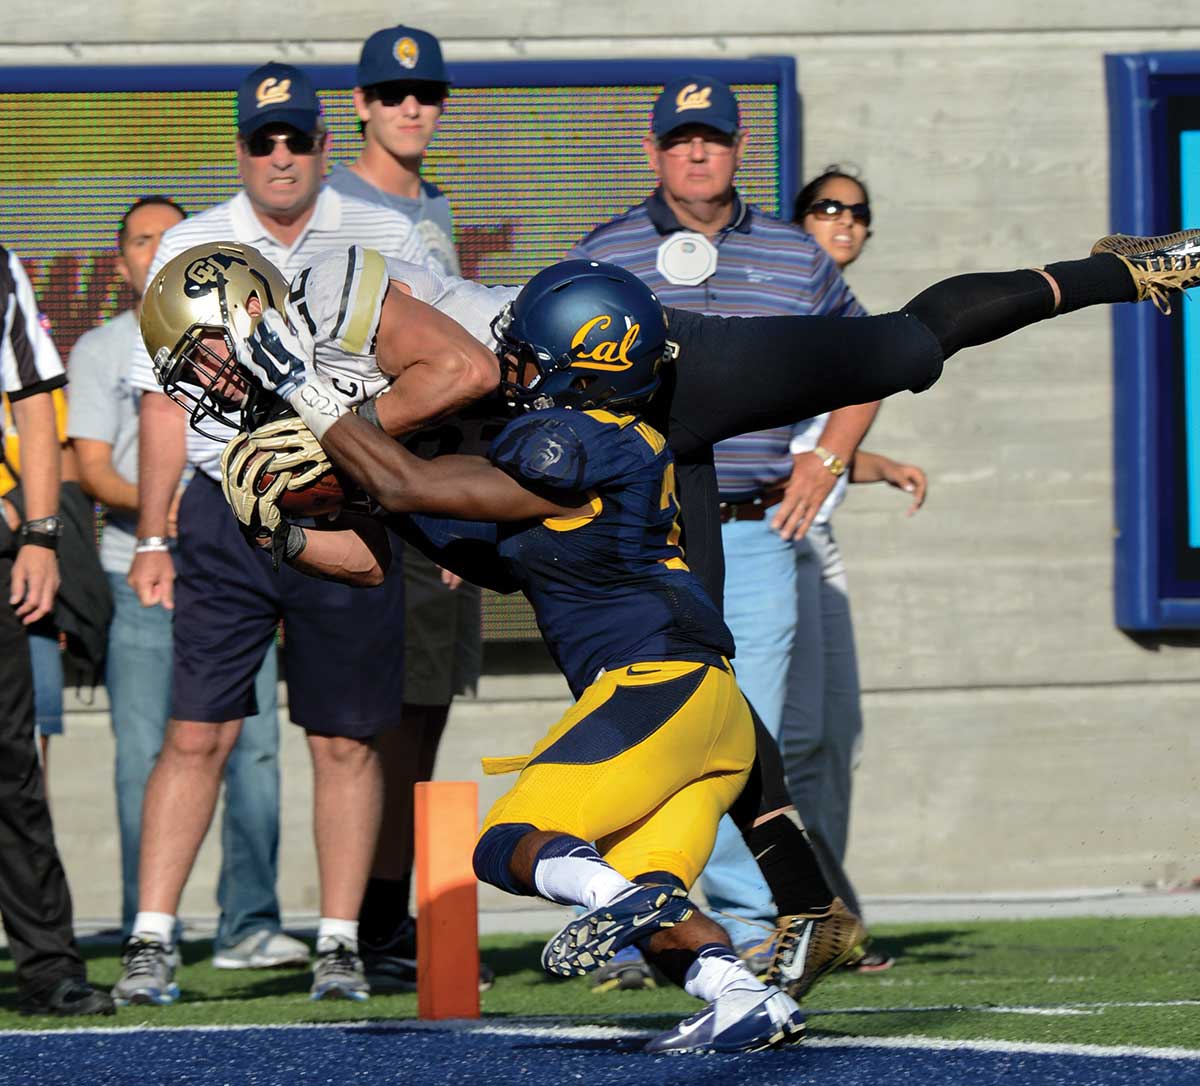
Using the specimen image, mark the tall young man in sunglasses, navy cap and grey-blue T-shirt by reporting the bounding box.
[329,26,490,990]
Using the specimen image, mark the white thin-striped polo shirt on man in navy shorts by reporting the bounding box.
[130,185,438,480]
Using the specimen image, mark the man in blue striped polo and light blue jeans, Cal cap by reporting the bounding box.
[571,74,878,986]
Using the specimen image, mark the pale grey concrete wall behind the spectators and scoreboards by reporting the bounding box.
[11,0,1200,893]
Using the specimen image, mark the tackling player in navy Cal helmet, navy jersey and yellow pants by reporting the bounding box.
[226,262,804,1051]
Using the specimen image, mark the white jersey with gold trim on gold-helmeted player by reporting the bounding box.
[288,245,520,407]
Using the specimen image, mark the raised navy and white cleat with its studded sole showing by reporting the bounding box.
[541,886,696,977]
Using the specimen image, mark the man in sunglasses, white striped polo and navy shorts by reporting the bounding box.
[114,62,465,1003]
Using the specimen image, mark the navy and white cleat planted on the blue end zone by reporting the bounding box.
[646,988,804,1054]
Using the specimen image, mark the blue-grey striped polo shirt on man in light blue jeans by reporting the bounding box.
[570,188,865,498]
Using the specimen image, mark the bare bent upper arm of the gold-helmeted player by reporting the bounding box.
[376,282,500,436]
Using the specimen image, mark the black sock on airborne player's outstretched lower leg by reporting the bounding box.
[904,253,1138,358]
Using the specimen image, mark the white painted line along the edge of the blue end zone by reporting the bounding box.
[0,1000,1200,1061]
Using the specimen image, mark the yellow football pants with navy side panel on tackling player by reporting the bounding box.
[484,660,755,887]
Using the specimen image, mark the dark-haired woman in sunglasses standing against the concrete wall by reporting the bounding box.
[780,166,926,972]
